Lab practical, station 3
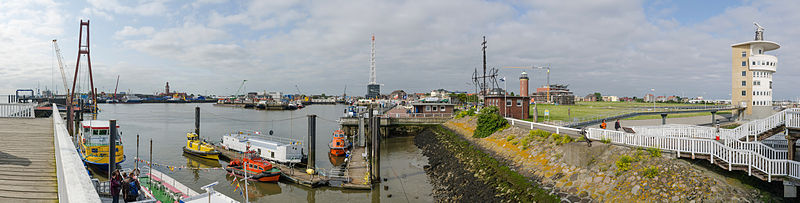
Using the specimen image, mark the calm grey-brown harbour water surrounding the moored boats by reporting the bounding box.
[92,103,433,202]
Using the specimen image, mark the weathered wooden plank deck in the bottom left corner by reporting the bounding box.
[0,118,58,202]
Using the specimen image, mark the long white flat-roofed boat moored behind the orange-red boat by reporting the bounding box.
[220,131,305,163]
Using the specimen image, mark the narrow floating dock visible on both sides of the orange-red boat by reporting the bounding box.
[214,146,328,188]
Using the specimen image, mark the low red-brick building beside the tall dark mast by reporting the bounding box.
[485,95,530,119]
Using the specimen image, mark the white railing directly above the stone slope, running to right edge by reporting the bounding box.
[586,128,800,182]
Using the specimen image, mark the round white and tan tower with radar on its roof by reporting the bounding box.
[731,24,781,119]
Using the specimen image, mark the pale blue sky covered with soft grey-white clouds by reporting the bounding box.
[0,0,800,100]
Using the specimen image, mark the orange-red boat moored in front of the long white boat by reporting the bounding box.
[225,151,281,182]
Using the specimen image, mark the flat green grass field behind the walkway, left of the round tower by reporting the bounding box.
[529,102,731,122]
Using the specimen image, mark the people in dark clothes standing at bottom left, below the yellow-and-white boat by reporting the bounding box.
[109,169,140,203]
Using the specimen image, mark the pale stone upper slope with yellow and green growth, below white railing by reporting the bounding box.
[440,117,772,202]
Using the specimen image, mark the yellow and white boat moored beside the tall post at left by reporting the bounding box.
[78,120,125,171]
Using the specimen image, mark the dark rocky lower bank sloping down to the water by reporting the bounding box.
[414,126,559,202]
